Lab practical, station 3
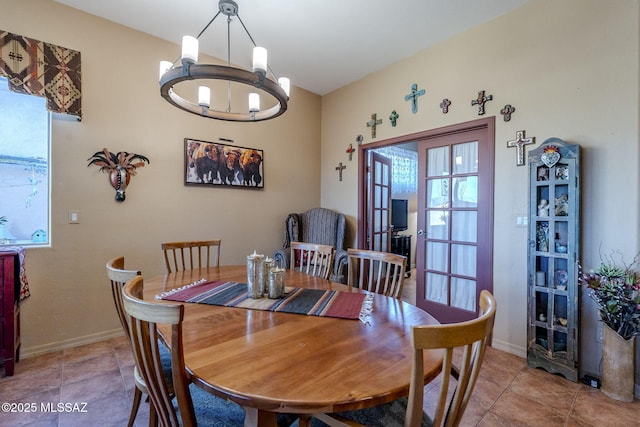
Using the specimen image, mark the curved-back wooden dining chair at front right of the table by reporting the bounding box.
[314,290,496,427]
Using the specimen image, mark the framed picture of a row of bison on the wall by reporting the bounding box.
[184,138,264,188]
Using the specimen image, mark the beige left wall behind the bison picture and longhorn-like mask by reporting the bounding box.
[0,0,320,355]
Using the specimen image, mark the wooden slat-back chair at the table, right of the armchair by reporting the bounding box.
[347,248,407,299]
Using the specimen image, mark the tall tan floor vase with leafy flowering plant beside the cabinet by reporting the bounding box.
[580,254,640,402]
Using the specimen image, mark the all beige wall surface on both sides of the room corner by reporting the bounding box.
[5,0,640,388]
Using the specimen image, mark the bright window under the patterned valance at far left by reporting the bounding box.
[0,76,51,247]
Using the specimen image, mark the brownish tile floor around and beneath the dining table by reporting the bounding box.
[0,272,640,427]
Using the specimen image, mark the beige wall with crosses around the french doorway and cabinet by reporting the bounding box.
[322,0,639,382]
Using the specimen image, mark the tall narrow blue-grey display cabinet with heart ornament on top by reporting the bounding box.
[527,138,580,381]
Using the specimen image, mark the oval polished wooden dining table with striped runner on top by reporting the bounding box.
[144,265,442,427]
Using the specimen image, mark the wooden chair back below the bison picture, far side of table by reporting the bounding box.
[161,239,221,273]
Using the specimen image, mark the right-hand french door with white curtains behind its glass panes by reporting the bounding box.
[416,122,494,323]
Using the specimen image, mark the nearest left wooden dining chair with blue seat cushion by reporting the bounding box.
[122,276,245,427]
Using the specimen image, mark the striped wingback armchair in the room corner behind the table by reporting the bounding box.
[273,208,348,282]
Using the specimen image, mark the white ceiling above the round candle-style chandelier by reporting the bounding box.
[55,0,528,95]
